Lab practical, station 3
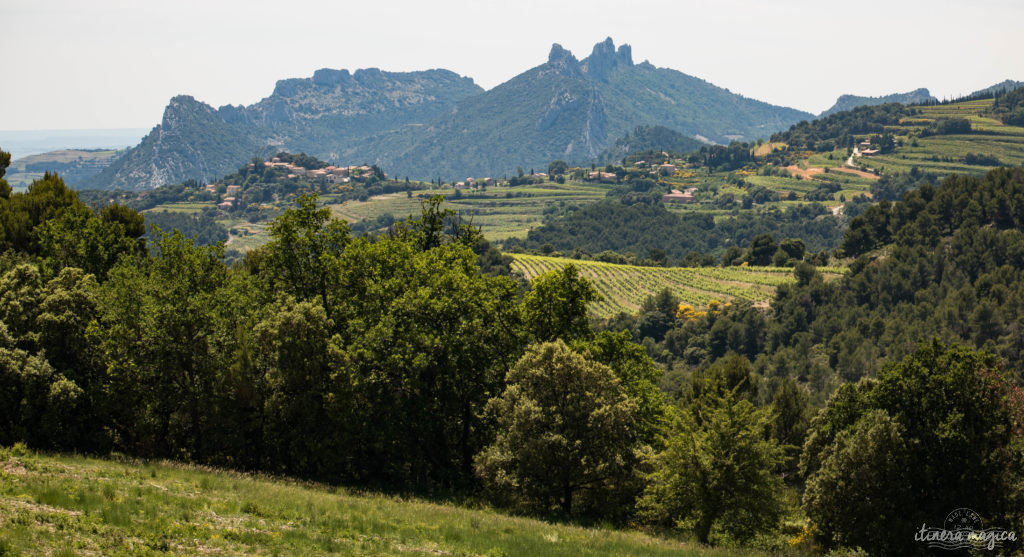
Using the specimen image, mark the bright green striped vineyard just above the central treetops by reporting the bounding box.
[512,254,846,317]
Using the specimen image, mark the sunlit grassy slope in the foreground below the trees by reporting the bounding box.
[0,448,753,556]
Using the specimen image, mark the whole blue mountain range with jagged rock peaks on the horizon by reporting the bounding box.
[90,39,812,189]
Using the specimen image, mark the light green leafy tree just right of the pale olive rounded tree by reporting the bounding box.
[639,382,784,544]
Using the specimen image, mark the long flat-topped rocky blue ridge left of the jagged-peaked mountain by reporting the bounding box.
[88,69,482,189]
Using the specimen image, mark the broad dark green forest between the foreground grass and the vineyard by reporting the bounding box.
[0,140,1024,555]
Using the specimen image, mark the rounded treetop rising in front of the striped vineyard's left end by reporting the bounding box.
[522,263,601,342]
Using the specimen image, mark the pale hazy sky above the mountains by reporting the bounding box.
[0,0,1024,130]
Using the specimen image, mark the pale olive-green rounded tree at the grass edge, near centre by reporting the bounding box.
[476,340,641,515]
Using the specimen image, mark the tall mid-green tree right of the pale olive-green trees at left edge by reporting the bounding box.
[91,230,241,462]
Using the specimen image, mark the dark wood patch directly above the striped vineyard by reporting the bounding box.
[504,202,843,261]
